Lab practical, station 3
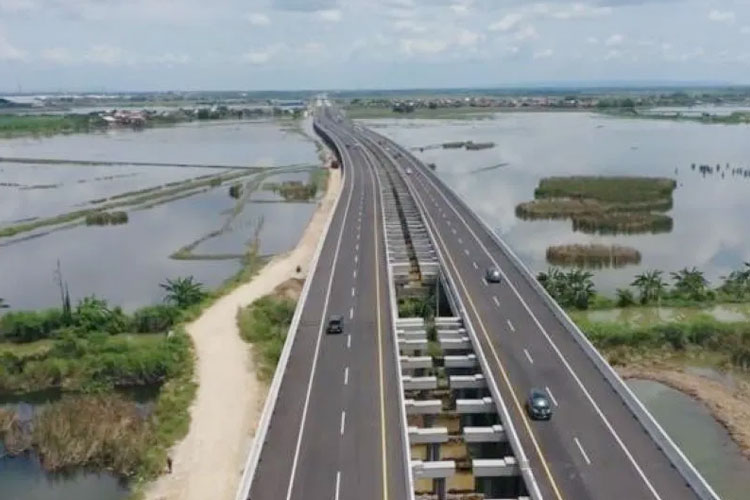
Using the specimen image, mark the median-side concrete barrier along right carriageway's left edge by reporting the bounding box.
[362,132,542,500]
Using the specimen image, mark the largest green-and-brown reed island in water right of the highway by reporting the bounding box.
[516,176,677,234]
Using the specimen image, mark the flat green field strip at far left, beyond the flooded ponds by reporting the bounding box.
[0,114,106,137]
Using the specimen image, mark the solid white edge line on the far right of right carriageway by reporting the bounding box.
[412,161,661,500]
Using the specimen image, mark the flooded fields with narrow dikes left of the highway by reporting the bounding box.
[0,122,318,310]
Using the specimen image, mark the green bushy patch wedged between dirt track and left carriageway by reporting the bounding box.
[237,295,296,380]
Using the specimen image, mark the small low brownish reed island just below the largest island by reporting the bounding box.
[547,244,641,268]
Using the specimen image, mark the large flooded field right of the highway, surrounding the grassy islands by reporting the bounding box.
[365,112,750,294]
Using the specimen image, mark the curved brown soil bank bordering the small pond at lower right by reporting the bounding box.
[616,363,750,459]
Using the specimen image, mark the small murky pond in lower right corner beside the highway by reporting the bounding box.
[627,379,750,500]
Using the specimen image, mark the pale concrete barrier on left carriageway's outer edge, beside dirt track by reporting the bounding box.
[235,123,346,500]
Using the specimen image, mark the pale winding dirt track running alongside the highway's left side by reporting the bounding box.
[145,170,341,500]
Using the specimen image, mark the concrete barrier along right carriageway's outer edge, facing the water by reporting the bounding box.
[390,134,720,500]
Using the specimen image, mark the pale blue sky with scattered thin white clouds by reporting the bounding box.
[0,0,750,92]
